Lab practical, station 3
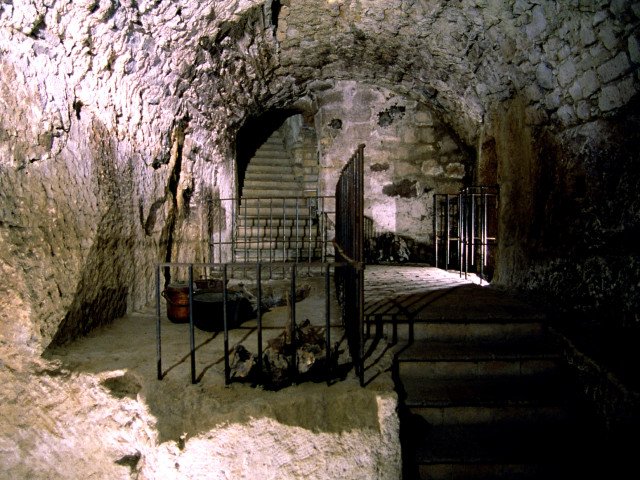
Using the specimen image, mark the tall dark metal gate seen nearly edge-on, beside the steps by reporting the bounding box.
[334,144,365,385]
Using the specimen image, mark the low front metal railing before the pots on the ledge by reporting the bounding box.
[156,262,340,385]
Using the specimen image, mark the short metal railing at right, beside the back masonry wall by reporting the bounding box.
[433,185,499,281]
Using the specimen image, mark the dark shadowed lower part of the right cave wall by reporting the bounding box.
[490,99,640,330]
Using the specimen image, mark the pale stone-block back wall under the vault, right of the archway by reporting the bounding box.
[316,81,474,255]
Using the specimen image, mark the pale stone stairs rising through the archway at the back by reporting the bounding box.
[234,131,322,262]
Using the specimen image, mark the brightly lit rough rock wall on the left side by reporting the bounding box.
[0,1,248,350]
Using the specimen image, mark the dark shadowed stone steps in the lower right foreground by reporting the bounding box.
[362,270,607,480]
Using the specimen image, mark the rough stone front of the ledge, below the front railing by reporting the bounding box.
[0,339,401,480]
